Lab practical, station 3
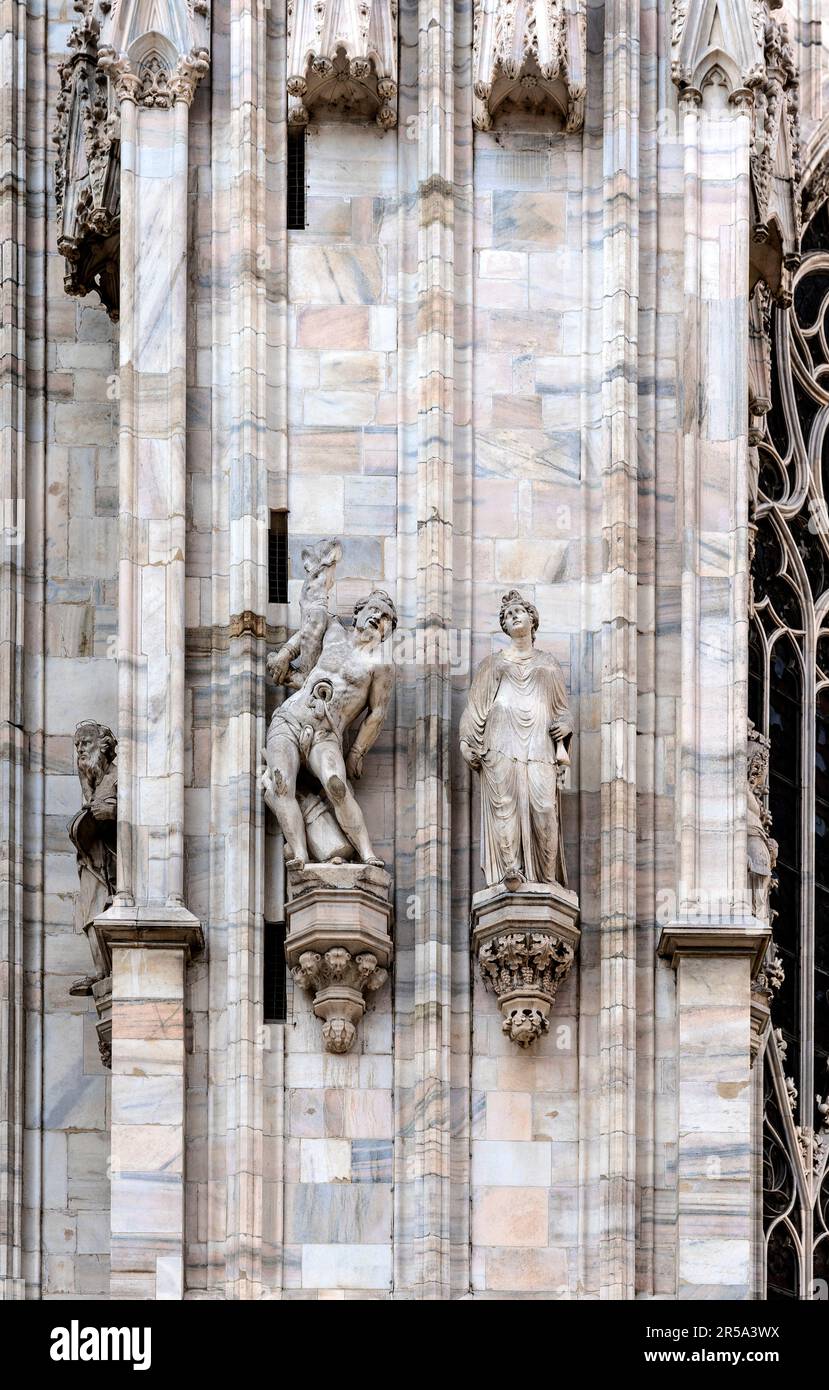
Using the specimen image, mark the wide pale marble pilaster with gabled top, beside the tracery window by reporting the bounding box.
[659,0,765,1298]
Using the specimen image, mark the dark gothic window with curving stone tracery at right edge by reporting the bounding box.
[750,204,829,1300]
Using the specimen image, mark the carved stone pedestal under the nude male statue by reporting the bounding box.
[285,863,392,1052]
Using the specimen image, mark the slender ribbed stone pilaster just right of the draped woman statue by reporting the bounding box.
[598,0,640,1298]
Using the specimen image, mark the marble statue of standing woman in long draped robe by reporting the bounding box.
[460,589,573,891]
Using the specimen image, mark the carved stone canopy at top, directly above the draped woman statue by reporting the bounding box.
[473,0,587,131]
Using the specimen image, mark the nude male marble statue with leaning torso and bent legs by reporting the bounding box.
[261,589,398,869]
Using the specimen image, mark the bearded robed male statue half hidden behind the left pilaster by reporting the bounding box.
[68,719,118,994]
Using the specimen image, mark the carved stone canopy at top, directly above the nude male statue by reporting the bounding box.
[288,0,398,131]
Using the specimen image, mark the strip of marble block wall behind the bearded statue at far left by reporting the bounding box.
[22,7,118,1297]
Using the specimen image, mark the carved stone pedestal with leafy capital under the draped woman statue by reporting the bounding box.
[472,883,580,1047]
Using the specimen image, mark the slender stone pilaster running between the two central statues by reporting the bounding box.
[413,0,455,1298]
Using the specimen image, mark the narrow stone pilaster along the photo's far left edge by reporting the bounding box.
[0,0,26,1298]
